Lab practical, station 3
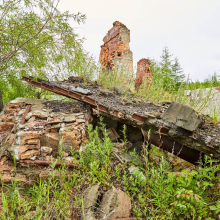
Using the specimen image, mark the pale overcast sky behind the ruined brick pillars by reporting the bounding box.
[59,0,220,81]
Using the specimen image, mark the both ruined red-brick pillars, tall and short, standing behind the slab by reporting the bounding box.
[99,21,151,90]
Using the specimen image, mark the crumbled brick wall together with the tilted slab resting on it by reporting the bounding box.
[0,77,220,181]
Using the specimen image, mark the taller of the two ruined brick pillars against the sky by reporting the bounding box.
[99,21,133,75]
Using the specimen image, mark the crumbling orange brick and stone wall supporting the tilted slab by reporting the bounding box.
[0,98,90,182]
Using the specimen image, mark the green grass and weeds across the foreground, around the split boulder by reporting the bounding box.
[0,124,220,220]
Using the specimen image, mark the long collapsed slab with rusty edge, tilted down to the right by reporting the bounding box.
[22,77,220,164]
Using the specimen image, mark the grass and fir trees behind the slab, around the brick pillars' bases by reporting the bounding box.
[98,47,220,122]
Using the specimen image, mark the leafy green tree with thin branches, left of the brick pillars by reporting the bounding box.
[0,0,96,103]
